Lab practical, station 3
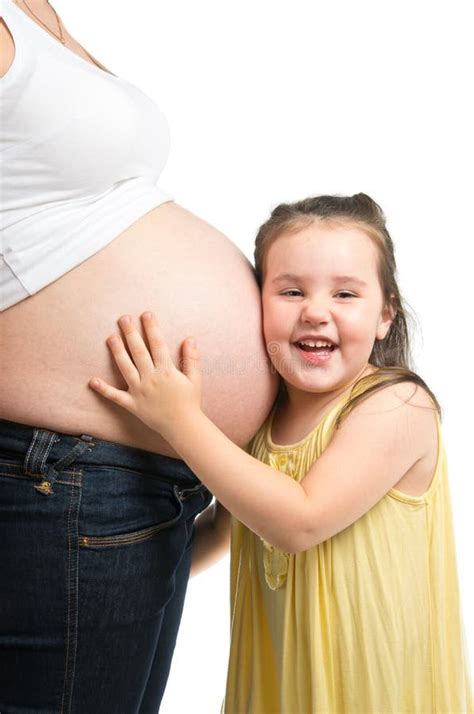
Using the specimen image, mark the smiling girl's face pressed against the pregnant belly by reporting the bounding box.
[262,220,393,392]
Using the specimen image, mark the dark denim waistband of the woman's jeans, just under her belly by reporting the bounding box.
[0,419,199,486]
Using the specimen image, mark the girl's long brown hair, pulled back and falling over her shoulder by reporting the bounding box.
[254,193,441,428]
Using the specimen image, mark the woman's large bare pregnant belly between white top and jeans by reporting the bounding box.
[0,202,276,456]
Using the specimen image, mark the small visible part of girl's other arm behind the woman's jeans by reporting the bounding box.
[191,501,230,577]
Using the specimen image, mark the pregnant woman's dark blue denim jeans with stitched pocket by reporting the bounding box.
[0,420,212,714]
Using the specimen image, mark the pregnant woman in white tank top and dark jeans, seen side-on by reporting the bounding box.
[0,0,276,714]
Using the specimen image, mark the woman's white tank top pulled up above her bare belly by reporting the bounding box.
[0,0,173,310]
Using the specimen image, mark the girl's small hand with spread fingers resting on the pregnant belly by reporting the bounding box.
[89,312,201,440]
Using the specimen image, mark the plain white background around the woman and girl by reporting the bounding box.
[63,0,474,714]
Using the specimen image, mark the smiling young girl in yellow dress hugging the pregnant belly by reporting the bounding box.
[91,194,473,714]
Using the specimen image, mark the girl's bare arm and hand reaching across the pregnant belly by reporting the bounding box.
[90,313,432,552]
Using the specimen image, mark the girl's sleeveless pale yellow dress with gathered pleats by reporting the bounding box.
[222,378,474,714]
